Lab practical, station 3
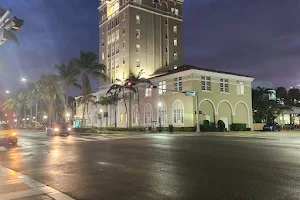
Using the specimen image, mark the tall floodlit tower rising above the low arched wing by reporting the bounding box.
[98,0,184,83]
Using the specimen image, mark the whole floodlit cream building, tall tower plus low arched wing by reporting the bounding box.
[76,0,254,130]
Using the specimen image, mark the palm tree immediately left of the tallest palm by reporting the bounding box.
[54,63,80,109]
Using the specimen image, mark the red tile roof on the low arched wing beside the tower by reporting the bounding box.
[150,65,254,79]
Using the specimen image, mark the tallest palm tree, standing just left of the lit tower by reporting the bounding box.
[70,51,106,125]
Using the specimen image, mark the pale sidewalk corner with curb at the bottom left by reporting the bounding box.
[0,166,73,200]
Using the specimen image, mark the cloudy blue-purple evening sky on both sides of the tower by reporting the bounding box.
[0,0,300,94]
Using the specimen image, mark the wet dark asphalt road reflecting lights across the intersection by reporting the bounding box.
[0,131,300,200]
